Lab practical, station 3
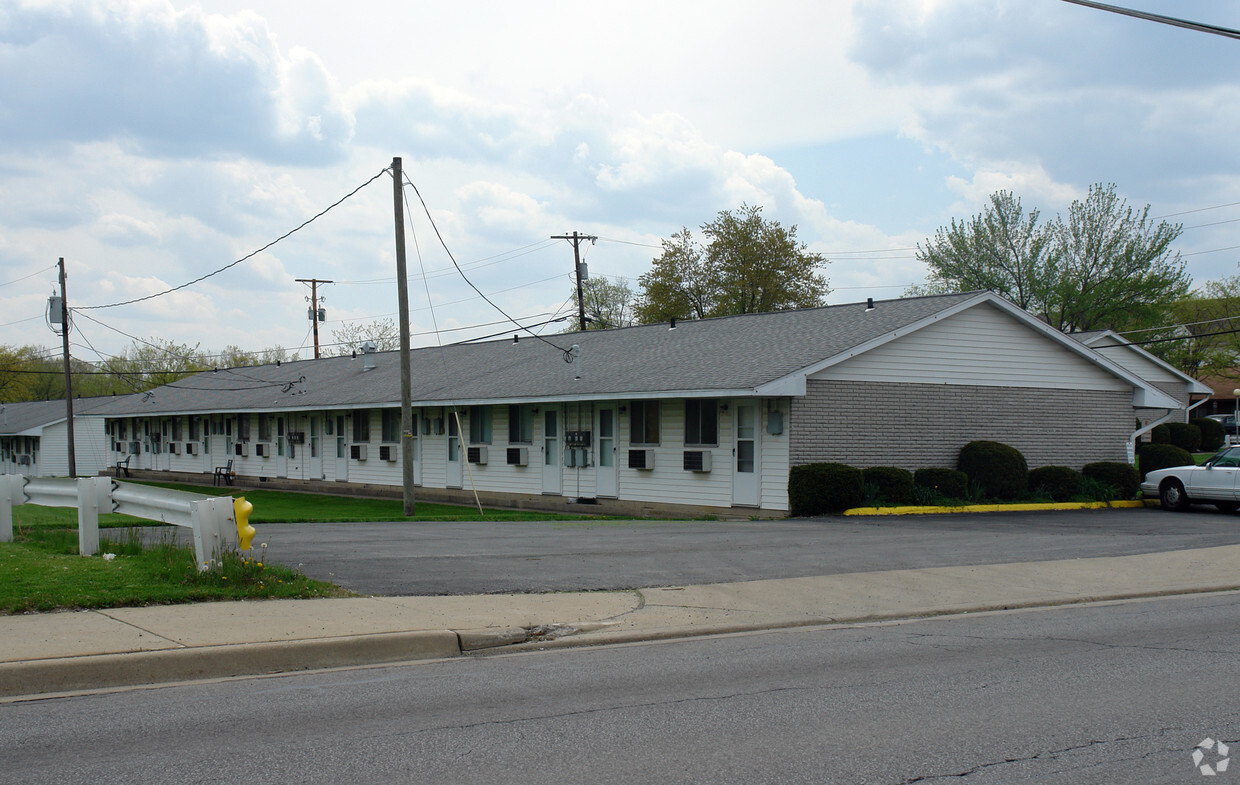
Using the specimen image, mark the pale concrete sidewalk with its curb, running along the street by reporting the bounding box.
[0,546,1240,698]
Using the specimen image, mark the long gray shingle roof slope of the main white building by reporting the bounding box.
[87,293,987,415]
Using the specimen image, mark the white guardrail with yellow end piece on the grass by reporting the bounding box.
[0,474,254,572]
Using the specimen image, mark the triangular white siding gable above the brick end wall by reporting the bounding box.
[810,304,1132,391]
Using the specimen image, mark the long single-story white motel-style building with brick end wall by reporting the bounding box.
[89,293,1179,516]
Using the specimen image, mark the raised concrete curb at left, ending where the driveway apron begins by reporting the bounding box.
[0,630,461,697]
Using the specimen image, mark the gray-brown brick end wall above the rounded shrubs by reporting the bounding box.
[789,379,1135,470]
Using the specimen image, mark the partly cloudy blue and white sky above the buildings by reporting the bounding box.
[0,0,1240,361]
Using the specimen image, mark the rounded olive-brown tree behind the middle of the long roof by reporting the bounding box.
[634,205,830,324]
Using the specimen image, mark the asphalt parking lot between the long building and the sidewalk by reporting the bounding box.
[241,507,1240,595]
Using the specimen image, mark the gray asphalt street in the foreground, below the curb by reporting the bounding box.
[0,594,1240,785]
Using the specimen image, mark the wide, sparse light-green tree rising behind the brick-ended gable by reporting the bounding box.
[910,185,1192,332]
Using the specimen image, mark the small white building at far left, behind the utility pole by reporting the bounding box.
[0,398,112,477]
